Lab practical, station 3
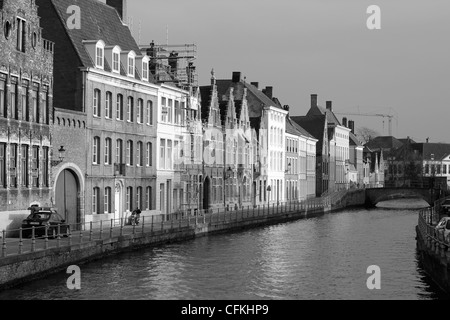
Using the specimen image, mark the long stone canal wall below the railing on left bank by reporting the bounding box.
[0,190,365,290]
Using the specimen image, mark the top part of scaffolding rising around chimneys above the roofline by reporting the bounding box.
[140,41,198,90]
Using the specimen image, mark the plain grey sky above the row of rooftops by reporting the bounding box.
[121,0,450,143]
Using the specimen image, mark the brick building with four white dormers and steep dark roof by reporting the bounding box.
[37,0,159,223]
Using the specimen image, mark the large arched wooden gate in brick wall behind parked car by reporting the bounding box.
[55,169,81,228]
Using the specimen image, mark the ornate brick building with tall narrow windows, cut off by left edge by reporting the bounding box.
[0,0,53,229]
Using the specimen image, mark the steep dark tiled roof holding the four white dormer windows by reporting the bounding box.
[49,0,141,67]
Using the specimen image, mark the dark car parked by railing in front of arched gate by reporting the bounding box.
[22,207,70,238]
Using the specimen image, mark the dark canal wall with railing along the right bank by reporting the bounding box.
[416,201,450,293]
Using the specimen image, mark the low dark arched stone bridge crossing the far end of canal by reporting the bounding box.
[366,187,438,206]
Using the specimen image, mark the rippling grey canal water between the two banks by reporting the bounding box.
[0,199,449,300]
